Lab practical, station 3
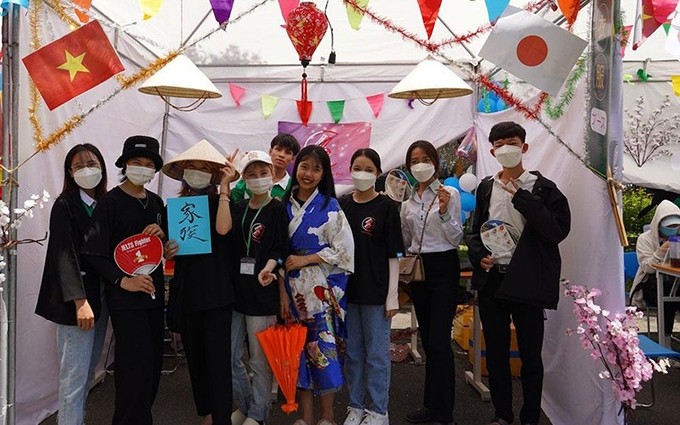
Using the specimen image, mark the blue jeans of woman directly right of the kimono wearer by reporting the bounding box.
[345,303,392,415]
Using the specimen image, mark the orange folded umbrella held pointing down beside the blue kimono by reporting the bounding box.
[256,323,307,414]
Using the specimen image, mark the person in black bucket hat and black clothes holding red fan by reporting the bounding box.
[82,136,166,425]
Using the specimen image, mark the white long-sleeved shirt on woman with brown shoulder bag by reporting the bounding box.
[400,180,463,254]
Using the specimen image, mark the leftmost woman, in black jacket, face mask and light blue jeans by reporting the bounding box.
[35,143,109,425]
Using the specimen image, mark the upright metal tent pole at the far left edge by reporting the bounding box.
[0,3,19,425]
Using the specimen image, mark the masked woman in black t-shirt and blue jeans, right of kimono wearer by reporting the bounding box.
[339,148,404,425]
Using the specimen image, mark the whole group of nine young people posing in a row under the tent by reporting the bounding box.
[36,118,570,425]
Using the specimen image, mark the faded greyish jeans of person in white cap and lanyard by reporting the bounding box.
[231,311,276,421]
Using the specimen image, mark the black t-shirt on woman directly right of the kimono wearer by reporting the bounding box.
[339,194,404,305]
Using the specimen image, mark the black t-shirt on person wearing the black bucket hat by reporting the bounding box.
[81,186,167,310]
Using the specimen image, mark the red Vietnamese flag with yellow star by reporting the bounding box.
[23,21,125,110]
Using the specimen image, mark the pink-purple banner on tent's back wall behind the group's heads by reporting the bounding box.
[279,121,371,184]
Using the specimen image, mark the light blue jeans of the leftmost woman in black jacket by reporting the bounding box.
[57,303,109,425]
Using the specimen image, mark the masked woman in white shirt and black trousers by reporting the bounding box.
[401,140,463,424]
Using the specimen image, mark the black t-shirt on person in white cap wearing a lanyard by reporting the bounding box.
[231,199,288,316]
